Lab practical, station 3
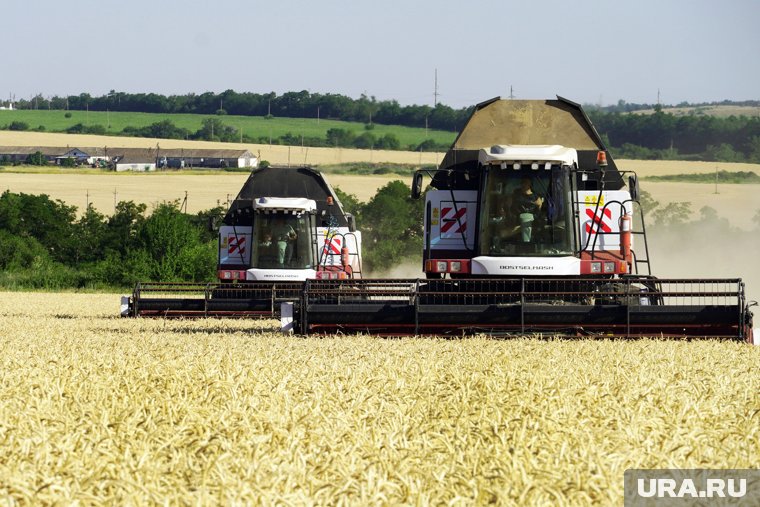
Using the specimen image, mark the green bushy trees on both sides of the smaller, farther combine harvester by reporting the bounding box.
[0,181,422,289]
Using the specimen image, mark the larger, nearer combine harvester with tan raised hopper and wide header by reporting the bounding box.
[297,98,752,342]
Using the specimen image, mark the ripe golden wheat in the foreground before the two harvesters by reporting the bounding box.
[0,293,760,505]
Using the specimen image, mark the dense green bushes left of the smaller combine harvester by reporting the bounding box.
[0,191,221,289]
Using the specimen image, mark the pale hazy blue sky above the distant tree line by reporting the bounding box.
[0,0,760,108]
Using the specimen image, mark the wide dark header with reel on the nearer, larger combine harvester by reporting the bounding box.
[300,276,751,339]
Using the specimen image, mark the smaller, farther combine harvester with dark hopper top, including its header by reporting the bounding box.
[122,167,361,317]
